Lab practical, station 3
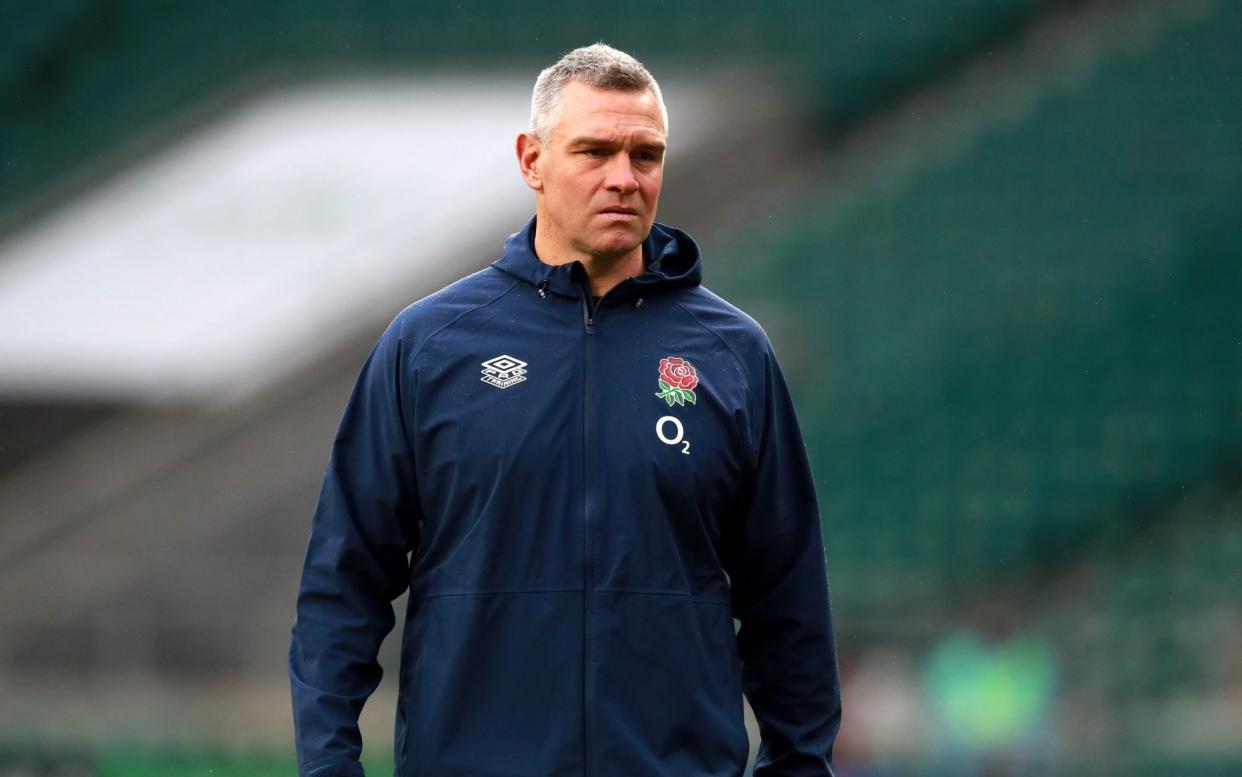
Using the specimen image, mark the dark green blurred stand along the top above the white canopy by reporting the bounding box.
[0,0,1053,228]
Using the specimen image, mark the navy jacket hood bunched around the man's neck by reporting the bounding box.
[492,216,703,299]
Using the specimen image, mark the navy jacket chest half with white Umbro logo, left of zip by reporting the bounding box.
[412,309,582,593]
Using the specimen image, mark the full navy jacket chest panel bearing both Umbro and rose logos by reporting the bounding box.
[404,296,746,597]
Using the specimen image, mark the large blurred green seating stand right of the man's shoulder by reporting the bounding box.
[715,0,1242,617]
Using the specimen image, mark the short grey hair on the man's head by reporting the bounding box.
[528,42,668,144]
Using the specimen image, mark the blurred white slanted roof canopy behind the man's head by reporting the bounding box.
[0,77,720,402]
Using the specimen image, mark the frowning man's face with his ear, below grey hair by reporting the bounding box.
[523,81,666,256]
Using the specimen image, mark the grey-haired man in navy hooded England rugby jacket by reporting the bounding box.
[289,45,841,777]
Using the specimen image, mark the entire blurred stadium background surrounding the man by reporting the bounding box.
[0,0,1242,777]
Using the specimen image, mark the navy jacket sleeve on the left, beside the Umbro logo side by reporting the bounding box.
[289,315,419,777]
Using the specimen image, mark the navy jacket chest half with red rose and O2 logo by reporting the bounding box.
[591,326,746,598]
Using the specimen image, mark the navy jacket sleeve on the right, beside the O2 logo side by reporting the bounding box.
[727,345,841,777]
